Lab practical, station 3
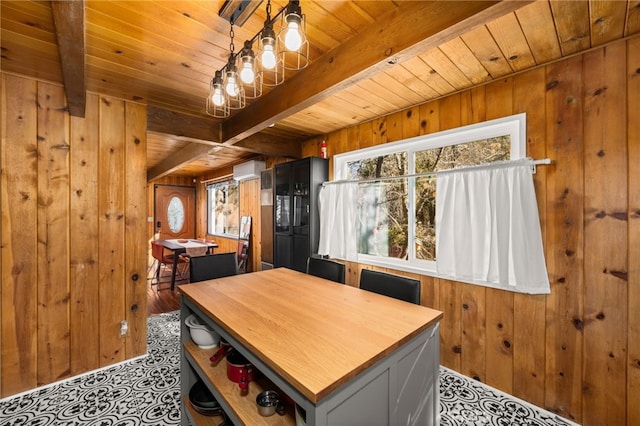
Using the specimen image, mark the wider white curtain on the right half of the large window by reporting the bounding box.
[436,160,550,294]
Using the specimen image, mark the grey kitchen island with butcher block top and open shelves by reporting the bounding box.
[180,268,442,426]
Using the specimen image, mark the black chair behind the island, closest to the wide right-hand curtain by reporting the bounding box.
[360,269,420,305]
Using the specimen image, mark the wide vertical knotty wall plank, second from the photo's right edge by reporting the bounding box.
[582,43,629,425]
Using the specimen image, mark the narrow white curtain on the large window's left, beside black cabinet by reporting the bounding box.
[318,183,358,261]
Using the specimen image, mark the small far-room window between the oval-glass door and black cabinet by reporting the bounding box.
[207,181,240,237]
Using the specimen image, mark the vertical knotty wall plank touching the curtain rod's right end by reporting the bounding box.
[545,56,584,422]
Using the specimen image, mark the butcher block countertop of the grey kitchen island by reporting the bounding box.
[180,268,442,404]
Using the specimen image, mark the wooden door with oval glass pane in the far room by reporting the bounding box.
[154,185,196,240]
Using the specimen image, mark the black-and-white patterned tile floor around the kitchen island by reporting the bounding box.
[0,312,574,426]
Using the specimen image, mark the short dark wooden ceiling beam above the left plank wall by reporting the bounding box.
[51,0,87,117]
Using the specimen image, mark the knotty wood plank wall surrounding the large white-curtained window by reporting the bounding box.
[303,37,640,426]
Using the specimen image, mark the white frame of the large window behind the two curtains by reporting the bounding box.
[333,113,527,275]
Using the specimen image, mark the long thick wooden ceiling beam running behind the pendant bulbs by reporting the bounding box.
[222,1,530,143]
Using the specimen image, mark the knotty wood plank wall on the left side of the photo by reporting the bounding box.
[0,74,147,397]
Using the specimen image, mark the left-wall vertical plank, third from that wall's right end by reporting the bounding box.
[69,94,100,375]
